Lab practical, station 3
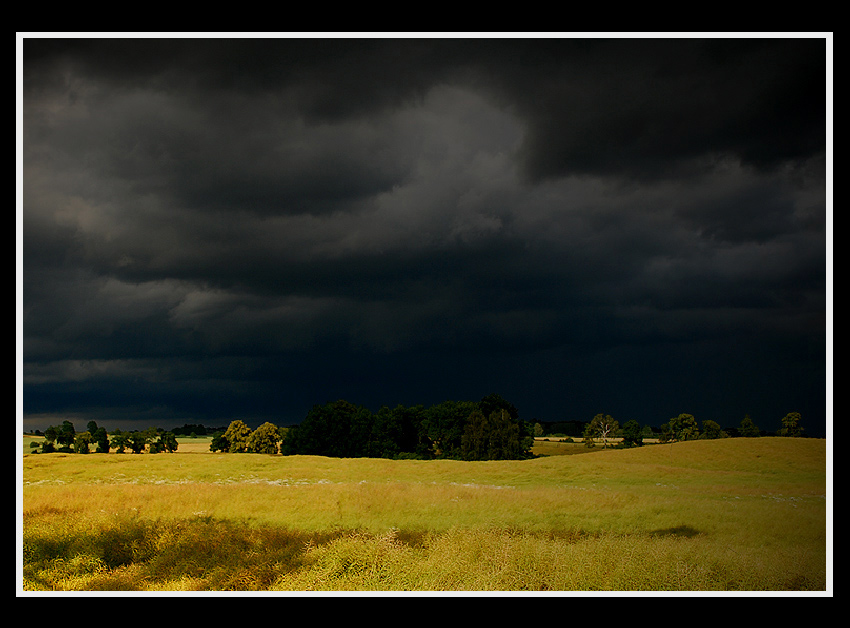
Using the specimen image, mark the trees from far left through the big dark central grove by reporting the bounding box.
[31,394,534,460]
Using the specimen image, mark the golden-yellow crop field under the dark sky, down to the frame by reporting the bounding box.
[21,438,831,592]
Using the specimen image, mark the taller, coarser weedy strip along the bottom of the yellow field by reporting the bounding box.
[24,515,826,591]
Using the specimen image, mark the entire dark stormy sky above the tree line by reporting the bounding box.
[18,36,832,436]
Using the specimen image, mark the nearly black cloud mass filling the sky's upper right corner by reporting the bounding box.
[496,39,826,179]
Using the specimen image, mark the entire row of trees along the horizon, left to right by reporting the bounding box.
[31,404,804,460]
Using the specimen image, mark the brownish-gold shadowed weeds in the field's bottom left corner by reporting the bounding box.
[24,514,339,591]
